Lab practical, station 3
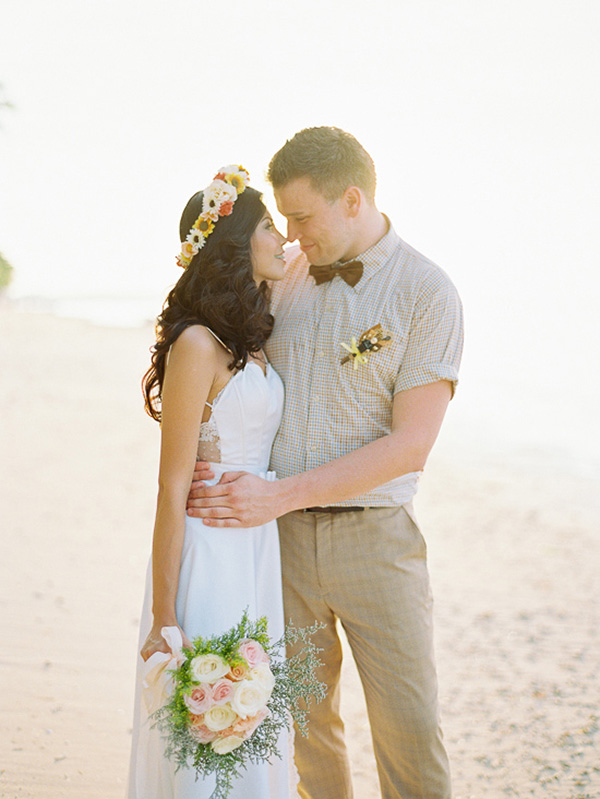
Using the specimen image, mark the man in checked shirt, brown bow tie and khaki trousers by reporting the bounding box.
[188,127,462,799]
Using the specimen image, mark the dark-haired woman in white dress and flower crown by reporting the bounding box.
[129,165,297,799]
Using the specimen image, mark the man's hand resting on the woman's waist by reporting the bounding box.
[187,462,278,527]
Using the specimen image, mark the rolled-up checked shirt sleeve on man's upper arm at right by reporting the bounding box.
[394,271,464,395]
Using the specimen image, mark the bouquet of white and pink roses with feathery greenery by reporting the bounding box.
[144,612,325,799]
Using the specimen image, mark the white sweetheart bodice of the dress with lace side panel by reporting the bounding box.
[197,362,283,470]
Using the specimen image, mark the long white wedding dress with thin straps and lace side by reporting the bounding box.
[128,362,297,799]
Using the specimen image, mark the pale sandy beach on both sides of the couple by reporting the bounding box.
[0,307,600,799]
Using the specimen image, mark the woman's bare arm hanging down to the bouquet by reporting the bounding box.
[141,325,217,660]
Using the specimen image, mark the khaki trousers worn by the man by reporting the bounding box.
[279,505,450,799]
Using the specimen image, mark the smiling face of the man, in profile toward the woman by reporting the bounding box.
[275,178,352,265]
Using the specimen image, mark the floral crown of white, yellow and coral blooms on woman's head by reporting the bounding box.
[177,164,250,269]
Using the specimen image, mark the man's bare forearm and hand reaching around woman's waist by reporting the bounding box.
[188,380,452,527]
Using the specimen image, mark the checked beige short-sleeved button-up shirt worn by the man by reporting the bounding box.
[266,220,463,507]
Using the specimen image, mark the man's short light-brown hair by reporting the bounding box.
[267,126,376,202]
